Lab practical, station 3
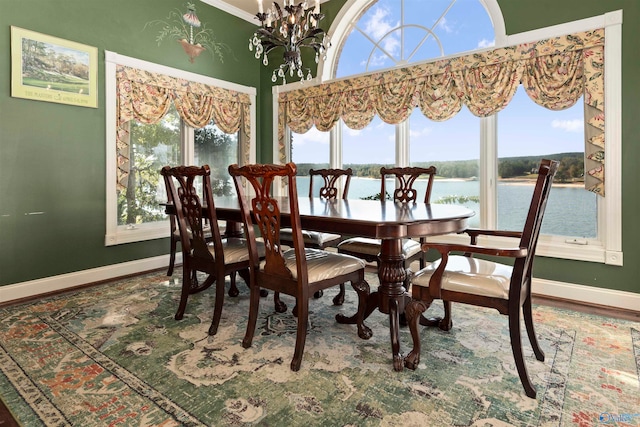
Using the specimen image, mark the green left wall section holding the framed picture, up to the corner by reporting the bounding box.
[0,0,261,292]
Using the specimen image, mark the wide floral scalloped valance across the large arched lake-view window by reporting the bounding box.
[278,29,605,196]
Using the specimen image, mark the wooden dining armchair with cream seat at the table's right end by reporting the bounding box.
[404,159,558,398]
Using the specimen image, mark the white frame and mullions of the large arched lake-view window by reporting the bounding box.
[273,5,623,266]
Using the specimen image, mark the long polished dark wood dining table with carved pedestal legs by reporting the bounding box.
[165,196,475,371]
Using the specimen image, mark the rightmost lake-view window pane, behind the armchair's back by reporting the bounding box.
[497,86,598,239]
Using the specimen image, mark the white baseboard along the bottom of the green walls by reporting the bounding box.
[0,253,640,311]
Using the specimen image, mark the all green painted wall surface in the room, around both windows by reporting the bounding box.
[0,0,640,300]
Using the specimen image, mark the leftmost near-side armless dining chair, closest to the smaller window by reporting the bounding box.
[160,165,264,335]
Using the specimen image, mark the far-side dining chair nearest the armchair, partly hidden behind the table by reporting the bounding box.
[336,166,437,290]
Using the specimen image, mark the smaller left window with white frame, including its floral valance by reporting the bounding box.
[105,52,255,245]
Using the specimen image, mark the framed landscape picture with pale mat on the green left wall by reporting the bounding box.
[11,26,98,108]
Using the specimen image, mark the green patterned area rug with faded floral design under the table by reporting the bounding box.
[0,273,640,427]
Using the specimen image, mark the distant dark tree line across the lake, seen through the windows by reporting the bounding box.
[297,153,584,182]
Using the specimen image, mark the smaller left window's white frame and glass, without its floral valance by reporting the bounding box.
[105,52,255,245]
